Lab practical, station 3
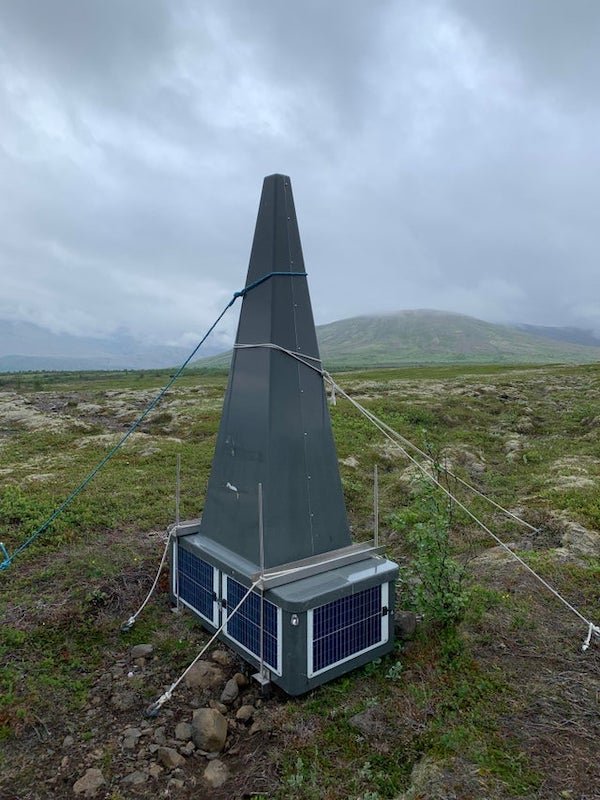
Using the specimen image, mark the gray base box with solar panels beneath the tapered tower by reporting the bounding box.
[171,533,398,695]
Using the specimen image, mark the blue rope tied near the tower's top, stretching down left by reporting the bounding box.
[0,272,306,572]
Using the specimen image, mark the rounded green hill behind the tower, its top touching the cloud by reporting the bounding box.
[197,310,600,369]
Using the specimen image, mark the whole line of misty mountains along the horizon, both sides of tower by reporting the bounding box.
[0,309,600,372]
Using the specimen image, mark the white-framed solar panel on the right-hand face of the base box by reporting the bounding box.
[308,584,389,677]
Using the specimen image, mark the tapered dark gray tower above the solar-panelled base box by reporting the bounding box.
[200,175,350,567]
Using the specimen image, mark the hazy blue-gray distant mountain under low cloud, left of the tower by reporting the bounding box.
[0,320,221,372]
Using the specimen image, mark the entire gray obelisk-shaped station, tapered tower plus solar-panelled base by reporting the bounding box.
[171,175,398,695]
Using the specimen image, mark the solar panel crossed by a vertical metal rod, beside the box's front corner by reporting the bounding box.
[224,576,281,675]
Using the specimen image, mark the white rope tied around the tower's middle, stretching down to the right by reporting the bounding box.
[226,342,600,651]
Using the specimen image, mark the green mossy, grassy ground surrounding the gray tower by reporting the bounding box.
[0,365,600,800]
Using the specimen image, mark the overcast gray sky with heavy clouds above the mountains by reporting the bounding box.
[0,0,600,344]
